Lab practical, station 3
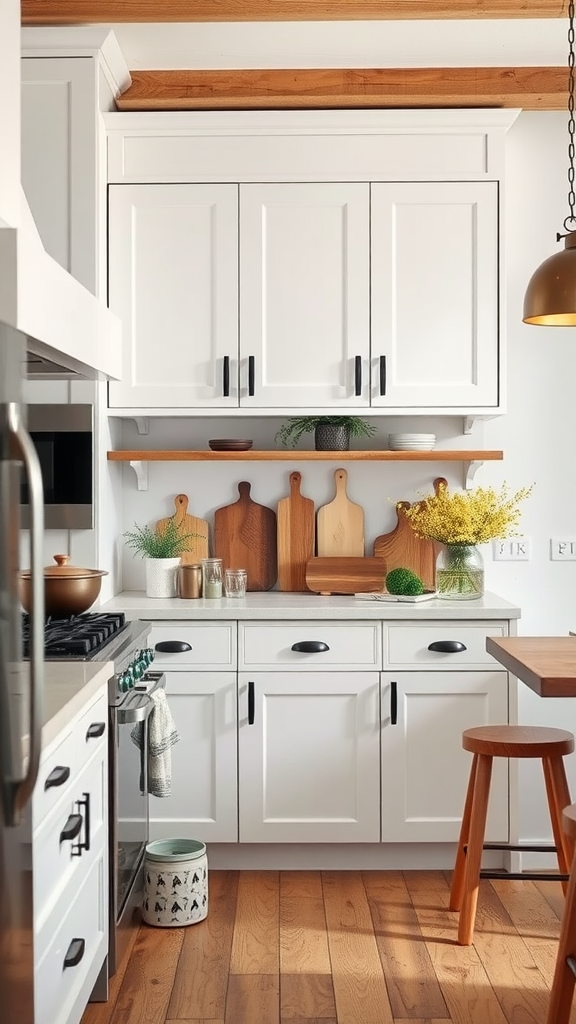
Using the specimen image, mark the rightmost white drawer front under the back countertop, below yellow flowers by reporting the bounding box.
[384,622,508,672]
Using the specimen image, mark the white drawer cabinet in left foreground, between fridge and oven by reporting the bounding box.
[32,686,108,1024]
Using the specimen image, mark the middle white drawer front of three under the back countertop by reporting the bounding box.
[239,622,381,672]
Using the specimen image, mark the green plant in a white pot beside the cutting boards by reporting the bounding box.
[124,518,193,597]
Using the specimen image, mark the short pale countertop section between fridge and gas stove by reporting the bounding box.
[42,662,114,751]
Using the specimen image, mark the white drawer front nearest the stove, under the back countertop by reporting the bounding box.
[149,622,236,672]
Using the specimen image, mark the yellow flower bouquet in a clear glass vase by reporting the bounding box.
[405,480,532,600]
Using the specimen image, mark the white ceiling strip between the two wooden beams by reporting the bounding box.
[103,18,568,70]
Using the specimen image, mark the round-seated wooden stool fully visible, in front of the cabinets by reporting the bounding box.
[450,725,574,946]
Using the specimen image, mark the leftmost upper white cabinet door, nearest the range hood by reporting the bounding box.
[110,184,238,409]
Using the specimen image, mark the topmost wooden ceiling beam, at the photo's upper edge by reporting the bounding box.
[22,0,568,25]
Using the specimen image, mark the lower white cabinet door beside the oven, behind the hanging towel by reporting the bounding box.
[147,671,238,843]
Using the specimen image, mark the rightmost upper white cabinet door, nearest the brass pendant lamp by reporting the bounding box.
[371,181,498,409]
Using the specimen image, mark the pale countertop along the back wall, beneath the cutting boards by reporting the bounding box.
[101,591,521,622]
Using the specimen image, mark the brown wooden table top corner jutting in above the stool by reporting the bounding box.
[486,636,576,697]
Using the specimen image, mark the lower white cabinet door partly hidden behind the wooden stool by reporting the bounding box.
[382,672,508,843]
